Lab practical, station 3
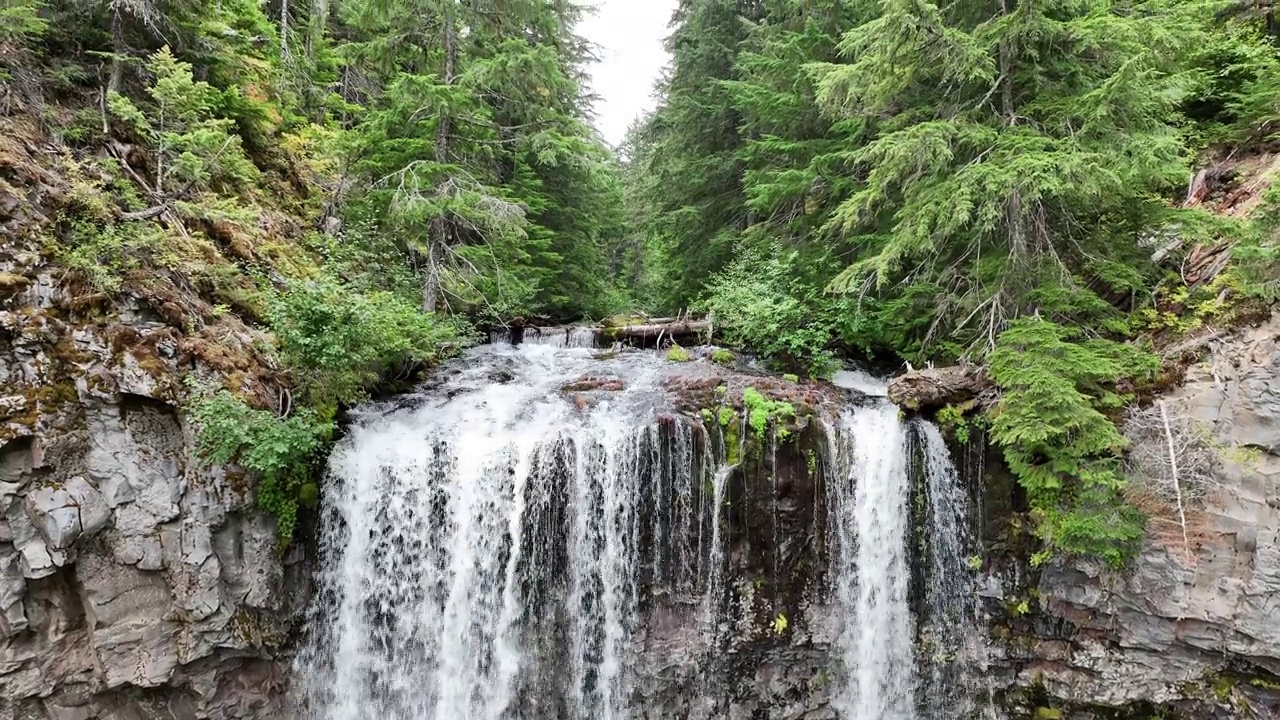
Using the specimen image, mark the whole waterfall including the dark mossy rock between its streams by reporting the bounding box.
[297,343,980,720]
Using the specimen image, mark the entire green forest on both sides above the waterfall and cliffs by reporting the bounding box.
[0,0,1280,564]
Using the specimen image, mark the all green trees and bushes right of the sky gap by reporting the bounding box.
[625,0,1280,562]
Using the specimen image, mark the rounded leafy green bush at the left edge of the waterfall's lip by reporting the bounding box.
[268,274,460,406]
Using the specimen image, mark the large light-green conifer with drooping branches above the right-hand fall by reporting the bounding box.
[812,0,1203,350]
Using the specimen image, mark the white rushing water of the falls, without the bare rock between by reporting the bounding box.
[298,334,974,720]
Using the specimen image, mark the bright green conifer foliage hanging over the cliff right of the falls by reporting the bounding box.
[991,318,1160,565]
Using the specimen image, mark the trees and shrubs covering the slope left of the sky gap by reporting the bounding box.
[0,0,628,538]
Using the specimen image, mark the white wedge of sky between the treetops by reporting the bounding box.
[577,0,677,146]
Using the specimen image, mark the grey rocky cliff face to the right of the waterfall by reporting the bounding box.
[986,318,1280,720]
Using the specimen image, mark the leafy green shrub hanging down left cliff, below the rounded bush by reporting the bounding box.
[187,389,334,542]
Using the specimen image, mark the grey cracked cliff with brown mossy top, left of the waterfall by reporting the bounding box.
[0,164,305,720]
